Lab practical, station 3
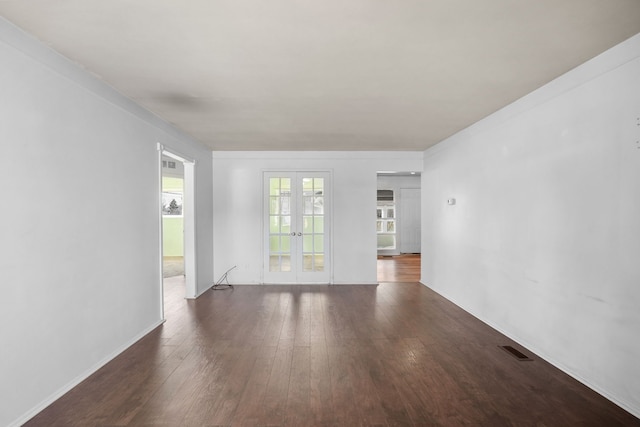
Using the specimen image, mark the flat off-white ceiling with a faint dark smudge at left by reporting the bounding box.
[0,0,640,150]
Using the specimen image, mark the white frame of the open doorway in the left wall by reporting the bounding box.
[158,143,197,319]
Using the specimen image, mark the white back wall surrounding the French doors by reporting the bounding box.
[213,152,422,284]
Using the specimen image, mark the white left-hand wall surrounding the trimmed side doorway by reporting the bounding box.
[0,19,213,426]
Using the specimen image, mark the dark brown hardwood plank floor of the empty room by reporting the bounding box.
[26,278,640,427]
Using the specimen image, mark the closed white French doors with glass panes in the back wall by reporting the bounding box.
[264,171,331,284]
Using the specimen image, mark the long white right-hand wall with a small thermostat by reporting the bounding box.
[422,35,640,416]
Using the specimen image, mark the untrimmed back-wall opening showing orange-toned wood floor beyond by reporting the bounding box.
[376,171,421,282]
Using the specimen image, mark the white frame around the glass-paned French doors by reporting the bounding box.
[261,168,333,285]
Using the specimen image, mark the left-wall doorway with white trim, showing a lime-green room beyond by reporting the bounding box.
[158,145,196,318]
